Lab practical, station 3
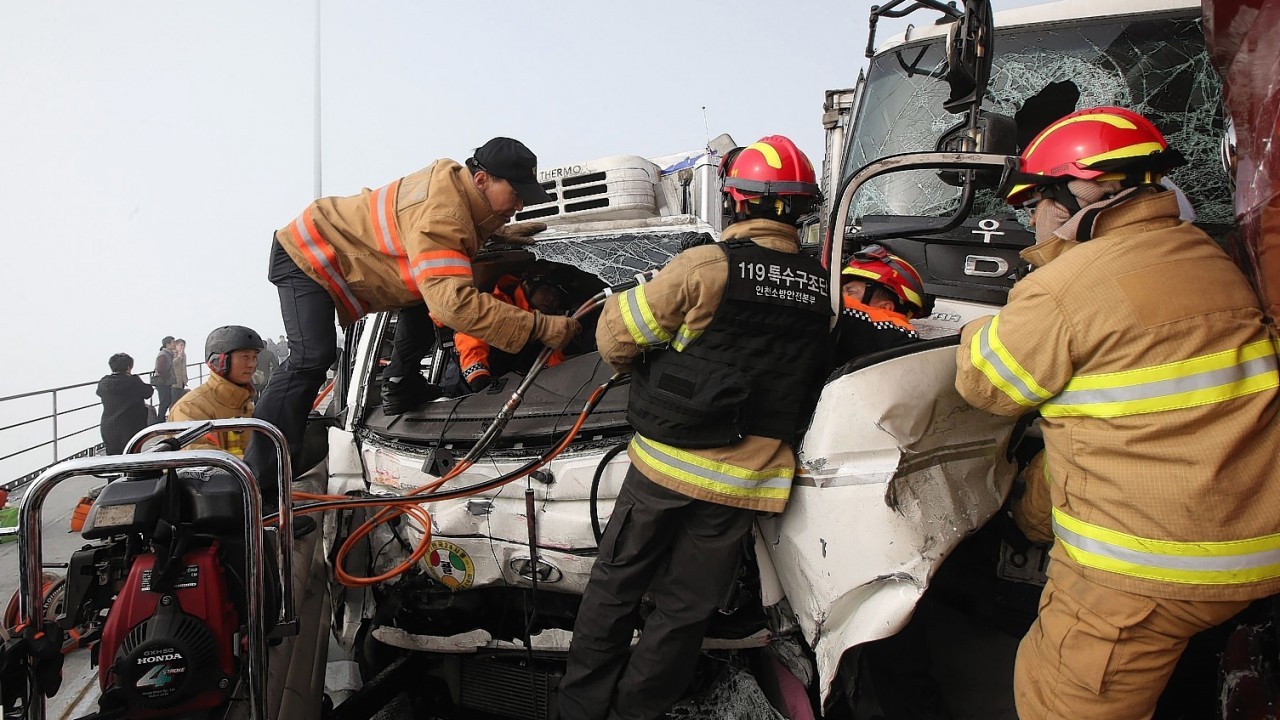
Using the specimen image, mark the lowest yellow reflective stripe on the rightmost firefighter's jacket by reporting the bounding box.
[1053,507,1280,585]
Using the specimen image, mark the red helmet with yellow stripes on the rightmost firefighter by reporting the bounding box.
[1005,106,1185,205]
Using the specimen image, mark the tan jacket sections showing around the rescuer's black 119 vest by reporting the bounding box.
[595,220,800,512]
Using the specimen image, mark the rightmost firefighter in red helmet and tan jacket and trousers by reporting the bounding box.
[956,108,1280,720]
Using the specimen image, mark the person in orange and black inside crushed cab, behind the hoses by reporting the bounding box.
[453,275,568,392]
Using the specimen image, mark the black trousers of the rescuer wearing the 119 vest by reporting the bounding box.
[559,468,755,720]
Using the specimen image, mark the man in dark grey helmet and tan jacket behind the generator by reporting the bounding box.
[169,325,262,457]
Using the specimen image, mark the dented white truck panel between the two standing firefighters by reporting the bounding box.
[760,346,1016,697]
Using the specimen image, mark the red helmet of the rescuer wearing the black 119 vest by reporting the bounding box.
[719,135,820,206]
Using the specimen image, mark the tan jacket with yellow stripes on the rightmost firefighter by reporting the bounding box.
[956,192,1280,600]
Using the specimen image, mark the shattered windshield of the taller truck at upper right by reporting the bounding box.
[844,13,1233,224]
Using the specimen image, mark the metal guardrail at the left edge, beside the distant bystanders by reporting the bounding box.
[0,363,206,492]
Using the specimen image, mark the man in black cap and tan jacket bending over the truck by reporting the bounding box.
[247,137,581,498]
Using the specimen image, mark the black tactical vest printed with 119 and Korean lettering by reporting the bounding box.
[627,240,831,448]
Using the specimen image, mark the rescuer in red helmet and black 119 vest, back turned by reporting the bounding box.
[559,136,831,720]
